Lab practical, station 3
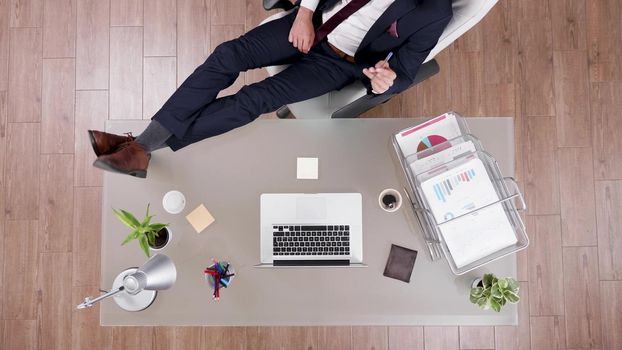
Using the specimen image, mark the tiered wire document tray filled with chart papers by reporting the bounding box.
[392,112,529,275]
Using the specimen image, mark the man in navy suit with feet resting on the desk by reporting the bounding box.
[89,0,452,177]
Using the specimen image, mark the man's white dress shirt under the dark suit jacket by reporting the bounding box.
[300,0,395,56]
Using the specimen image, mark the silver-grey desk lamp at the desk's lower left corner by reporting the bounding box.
[77,254,177,311]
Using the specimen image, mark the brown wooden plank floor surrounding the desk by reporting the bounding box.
[0,0,622,350]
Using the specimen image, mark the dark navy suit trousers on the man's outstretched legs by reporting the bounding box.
[153,11,363,150]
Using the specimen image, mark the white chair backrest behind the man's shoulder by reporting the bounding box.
[425,0,499,62]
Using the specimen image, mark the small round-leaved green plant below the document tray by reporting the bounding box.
[469,273,520,312]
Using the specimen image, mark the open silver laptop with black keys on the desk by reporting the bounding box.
[256,193,365,267]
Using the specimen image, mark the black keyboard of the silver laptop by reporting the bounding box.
[272,225,350,255]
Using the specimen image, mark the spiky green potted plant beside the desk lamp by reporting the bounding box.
[112,204,171,257]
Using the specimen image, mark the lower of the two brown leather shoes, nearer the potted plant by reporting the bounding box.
[93,141,151,178]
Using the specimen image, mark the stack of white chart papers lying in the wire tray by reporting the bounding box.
[396,113,517,268]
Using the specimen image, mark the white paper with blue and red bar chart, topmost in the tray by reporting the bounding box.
[421,158,517,267]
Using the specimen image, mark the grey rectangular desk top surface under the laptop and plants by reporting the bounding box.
[101,118,517,325]
